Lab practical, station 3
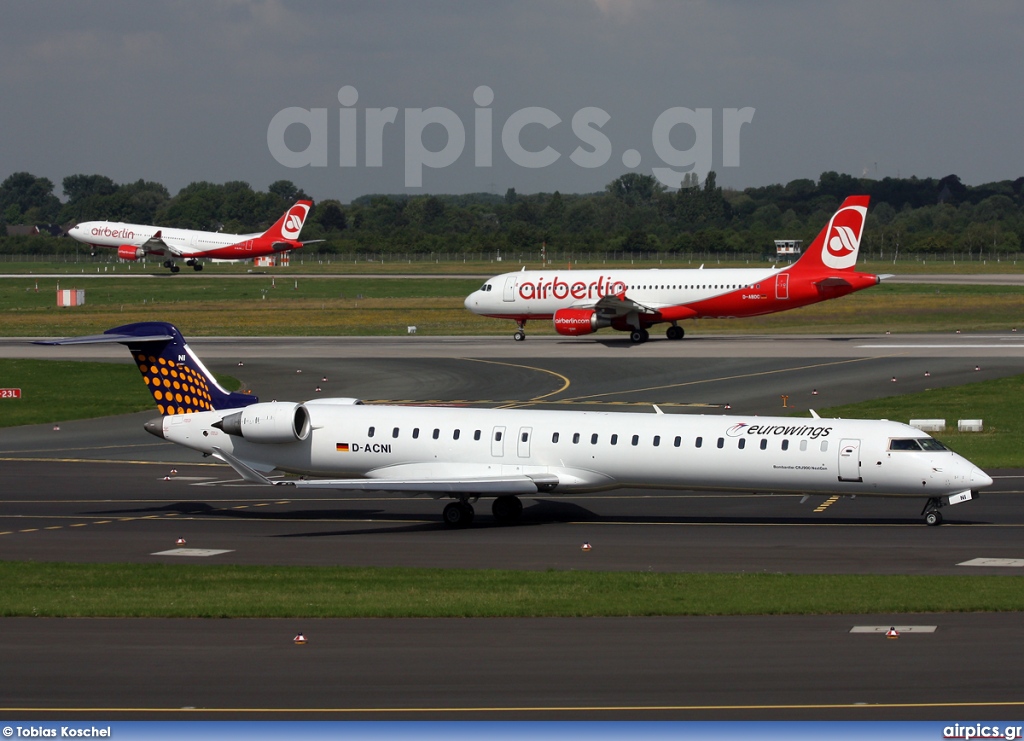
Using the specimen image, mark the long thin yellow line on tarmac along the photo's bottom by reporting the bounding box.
[6,700,1024,715]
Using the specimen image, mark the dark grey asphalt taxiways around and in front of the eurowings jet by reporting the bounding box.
[0,333,1024,720]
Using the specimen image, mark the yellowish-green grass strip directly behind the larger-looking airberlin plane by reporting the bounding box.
[0,277,1024,337]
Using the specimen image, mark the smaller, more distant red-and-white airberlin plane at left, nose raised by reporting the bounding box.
[68,201,323,272]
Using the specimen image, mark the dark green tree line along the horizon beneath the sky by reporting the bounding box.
[0,172,1024,255]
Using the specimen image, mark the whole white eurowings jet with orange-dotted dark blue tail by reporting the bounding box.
[40,322,992,526]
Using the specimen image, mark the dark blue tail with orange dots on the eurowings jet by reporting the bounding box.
[38,321,259,415]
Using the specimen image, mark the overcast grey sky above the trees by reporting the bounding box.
[0,0,1024,202]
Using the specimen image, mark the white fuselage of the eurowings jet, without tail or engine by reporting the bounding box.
[155,399,991,497]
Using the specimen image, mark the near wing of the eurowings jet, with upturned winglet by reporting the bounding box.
[213,447,558,496]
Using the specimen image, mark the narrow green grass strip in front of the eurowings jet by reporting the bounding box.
[0,561,1024,618]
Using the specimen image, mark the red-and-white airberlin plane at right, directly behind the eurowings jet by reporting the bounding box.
[466,195,888,342]
